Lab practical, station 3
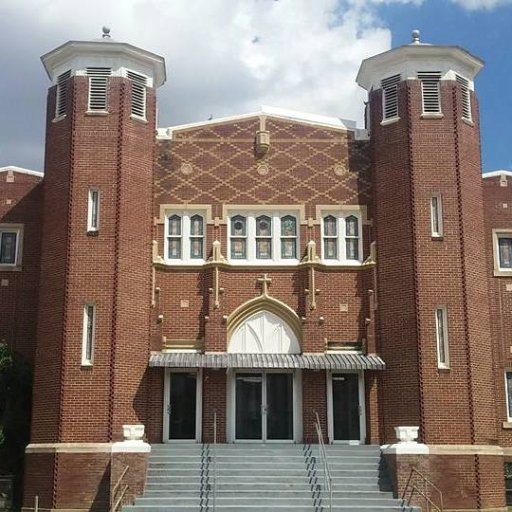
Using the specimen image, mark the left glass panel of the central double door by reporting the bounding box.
[235,373,263,439]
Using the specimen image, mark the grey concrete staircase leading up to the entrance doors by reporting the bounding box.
[123,443,416,512]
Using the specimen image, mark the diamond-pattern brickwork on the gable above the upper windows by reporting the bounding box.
[155,116,371,216]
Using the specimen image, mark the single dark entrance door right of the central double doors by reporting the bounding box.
[332,373,361,441]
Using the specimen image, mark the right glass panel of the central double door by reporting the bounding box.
[265,373,293,439]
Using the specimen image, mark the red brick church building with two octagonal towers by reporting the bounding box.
[0,32,512,511]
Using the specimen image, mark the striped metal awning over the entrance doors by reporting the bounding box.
[149,352,386,370]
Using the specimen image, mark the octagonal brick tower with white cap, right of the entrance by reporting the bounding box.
[357,31,504,510]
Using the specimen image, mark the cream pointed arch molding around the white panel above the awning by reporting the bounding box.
[227,295,302,353]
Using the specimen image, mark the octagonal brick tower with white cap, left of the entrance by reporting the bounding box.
[24,29,165,510]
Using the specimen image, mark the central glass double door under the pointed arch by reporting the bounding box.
[235,373,293,441]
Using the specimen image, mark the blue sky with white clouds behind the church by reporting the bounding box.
[0,0,512,171]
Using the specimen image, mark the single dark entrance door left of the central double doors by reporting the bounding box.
[167,372,197,440]
